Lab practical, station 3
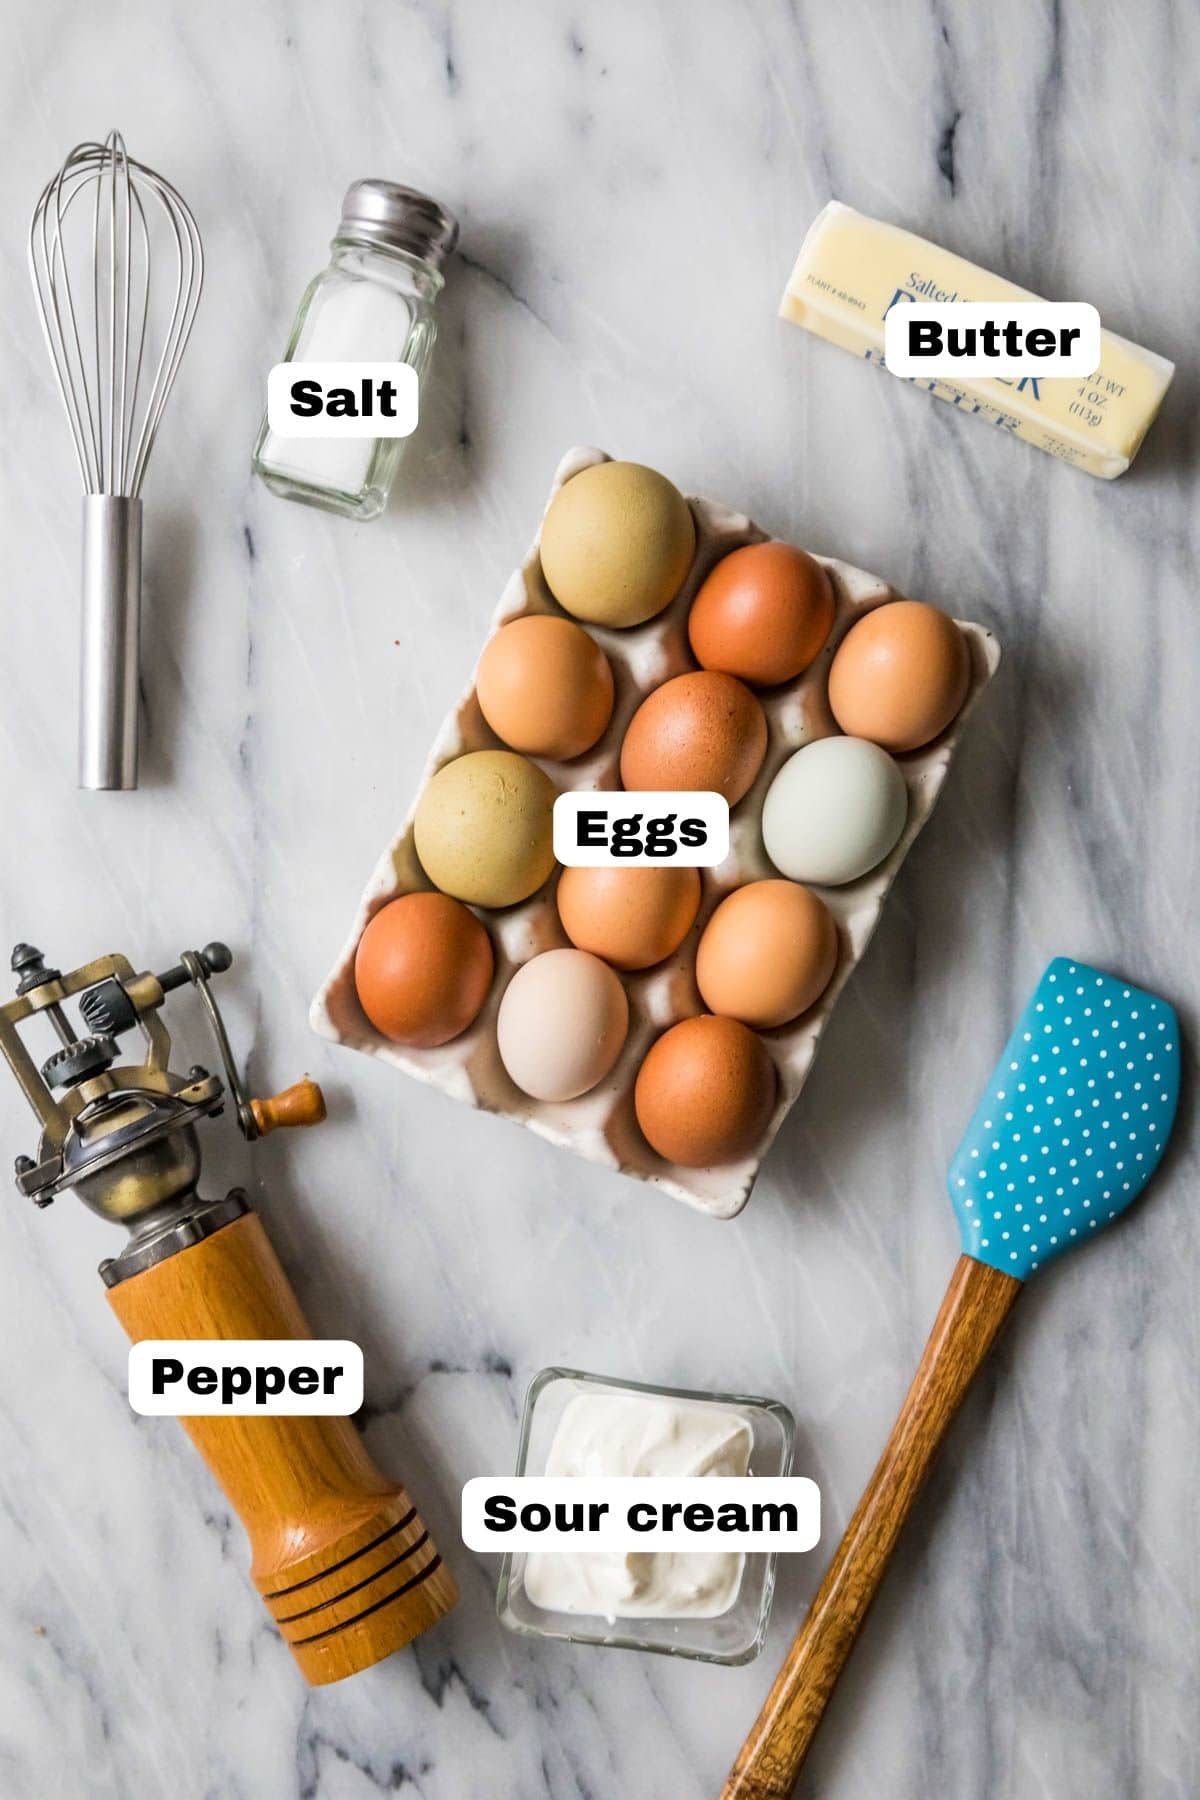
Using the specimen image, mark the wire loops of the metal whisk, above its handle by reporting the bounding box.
[29,131,203,497]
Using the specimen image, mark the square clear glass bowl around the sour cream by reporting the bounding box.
[497,1368,795,1663]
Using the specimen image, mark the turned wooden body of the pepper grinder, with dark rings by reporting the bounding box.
[108,1209,459,1685]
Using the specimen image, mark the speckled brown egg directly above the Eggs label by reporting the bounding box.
[621,670,766,806]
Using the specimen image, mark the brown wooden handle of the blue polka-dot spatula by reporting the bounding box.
[721,1256,1022,1800]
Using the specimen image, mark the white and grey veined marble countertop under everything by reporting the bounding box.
[0,0,1200,1800]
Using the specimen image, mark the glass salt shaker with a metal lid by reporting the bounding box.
[254,182,459,518]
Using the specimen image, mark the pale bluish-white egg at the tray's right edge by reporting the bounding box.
[763,738,909,887]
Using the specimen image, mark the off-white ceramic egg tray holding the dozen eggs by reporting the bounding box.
[311,450,1000,1219]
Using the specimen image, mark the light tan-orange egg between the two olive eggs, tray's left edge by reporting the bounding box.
[475,614,613,761]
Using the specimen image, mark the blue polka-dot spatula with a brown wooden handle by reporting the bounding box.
[721,958,1180,1800]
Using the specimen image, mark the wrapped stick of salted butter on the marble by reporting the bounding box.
[779,200,1175,481]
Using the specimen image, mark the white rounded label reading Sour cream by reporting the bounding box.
[462,1474,820,1553]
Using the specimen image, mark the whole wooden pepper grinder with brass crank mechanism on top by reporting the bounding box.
[0,943,457,1685]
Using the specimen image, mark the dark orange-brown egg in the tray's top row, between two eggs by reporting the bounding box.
[687,542,833,688]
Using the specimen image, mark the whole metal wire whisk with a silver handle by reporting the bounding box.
[29,131,203,788]
